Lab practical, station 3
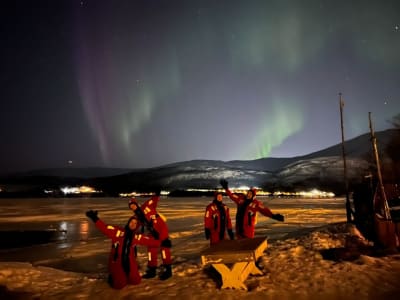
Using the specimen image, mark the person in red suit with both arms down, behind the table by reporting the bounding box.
[204,192,234,245]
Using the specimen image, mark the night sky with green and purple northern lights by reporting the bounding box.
[0,0,400,173]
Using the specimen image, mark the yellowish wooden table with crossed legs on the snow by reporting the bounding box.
[200,237,267,291]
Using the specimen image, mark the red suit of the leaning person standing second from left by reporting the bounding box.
[140,196,172,267]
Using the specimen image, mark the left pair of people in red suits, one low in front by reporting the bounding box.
[86,192,172,289]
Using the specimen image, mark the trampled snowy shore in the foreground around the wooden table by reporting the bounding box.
[0,222,400,299]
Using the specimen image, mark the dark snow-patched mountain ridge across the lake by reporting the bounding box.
[0,130,395,195]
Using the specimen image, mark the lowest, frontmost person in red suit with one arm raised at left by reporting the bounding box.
[86,210,160,289]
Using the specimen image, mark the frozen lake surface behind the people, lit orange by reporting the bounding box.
[0,197,346,272]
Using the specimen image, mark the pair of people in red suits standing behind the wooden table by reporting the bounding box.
[204,179,284,245]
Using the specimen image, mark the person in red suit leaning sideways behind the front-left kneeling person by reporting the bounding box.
[129,192,172,280]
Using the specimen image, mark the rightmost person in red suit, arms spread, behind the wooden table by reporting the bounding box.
[220,179,284,239]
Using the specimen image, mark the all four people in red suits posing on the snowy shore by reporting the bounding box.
[86,179,284,289]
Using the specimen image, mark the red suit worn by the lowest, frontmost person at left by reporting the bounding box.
[95,219,160,289]
